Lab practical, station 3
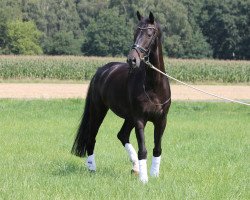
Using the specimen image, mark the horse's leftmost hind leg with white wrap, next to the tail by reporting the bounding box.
[87,104,108,171]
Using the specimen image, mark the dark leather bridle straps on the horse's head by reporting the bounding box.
[132,26,157,61]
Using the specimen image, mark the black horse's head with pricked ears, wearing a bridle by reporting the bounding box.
[127,11,161,68]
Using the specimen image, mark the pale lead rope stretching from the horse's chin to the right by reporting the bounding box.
[142,59,250,106]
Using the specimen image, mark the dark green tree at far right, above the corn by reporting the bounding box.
[199,0,250,59]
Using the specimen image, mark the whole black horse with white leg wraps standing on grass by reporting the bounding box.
[72,11,171,183]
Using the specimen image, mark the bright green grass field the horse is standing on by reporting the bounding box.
[0,99,250,200]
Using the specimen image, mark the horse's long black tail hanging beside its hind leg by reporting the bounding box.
[71,85,91,157]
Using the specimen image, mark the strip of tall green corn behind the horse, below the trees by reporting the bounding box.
[0,56,250,84]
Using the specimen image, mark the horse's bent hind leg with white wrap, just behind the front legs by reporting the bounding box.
[117,120,139,174]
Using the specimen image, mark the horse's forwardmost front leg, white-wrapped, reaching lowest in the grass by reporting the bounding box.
[135,121,148,183]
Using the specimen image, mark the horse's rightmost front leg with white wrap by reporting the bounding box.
[150,118,166,177]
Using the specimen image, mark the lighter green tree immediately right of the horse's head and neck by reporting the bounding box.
[153,0,211,58]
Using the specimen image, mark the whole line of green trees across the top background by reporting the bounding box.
[0,0,250,59]
